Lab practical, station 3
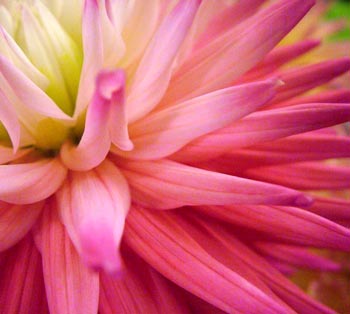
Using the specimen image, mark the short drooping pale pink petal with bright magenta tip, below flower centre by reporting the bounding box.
[57,160,130,273]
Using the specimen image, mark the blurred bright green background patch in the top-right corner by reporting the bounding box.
[326,0,350,40]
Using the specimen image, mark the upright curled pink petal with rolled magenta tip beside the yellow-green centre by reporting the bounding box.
[61,70,132,171]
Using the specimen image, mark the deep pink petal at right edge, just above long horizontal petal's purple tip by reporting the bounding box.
[243,162,350,190]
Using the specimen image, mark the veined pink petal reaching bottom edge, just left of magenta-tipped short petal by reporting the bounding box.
[38,202,99,314]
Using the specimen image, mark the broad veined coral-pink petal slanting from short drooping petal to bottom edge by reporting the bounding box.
[125,208,289,313]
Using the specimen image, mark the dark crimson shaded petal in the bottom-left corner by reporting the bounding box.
[0,236,49,314]
